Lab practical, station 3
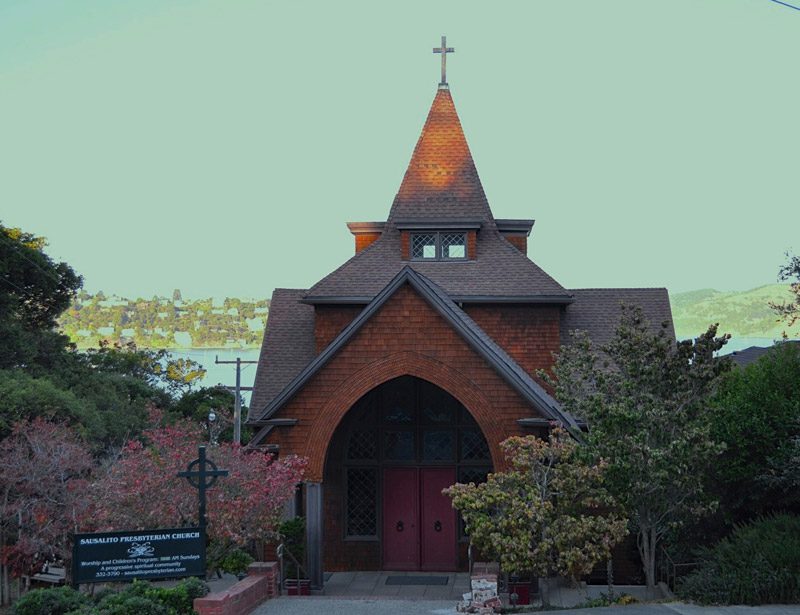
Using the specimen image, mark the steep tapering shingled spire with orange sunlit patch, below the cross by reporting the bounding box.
[388,88,492,223]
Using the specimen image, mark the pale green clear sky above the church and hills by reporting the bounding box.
[0,0,800,297]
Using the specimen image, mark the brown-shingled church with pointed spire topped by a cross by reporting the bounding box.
[248,41,674,587]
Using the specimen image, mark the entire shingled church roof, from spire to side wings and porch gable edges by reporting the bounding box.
[248,88,674,436]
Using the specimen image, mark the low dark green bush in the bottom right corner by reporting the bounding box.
[678,514,800,605]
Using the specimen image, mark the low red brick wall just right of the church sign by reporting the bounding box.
[194,562,278,615]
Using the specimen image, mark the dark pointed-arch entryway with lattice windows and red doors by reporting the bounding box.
[325,376,492,570]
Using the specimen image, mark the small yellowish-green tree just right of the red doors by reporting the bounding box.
[444,428,627,579]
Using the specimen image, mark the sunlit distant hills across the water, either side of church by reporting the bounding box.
[59,284,792,349]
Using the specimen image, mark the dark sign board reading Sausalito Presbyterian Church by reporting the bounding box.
[72,527,206,585]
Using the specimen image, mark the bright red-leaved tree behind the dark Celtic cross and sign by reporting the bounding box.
[91,415,306,572]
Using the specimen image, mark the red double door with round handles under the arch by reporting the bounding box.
[383,468,457,571]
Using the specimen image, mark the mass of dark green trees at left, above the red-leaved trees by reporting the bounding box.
[0,225,209,453]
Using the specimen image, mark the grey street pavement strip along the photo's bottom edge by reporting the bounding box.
[252,596,800,615]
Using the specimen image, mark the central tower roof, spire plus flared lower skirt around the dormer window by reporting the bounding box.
[306,88,571,303]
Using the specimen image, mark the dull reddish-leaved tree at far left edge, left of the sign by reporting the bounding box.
[0,419,93,604]
